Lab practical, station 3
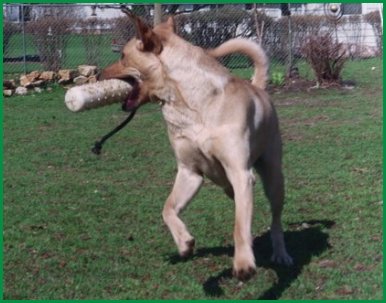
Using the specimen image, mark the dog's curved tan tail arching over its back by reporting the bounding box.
[207,38,268,89]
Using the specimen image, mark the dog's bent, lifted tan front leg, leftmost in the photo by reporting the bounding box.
[162,167,203,257]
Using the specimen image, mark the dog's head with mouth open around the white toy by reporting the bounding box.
[98,11,174,111]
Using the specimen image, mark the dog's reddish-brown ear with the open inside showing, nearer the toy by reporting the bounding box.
[122,10,162,55]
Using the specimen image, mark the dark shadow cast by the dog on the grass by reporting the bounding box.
[170,220,335,300]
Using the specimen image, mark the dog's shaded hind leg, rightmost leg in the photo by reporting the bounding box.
[254,146,293,265]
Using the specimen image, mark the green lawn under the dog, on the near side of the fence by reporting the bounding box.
[3,61,383,299]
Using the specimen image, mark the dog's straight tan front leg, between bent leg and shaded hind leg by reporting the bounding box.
[228,170,256,281]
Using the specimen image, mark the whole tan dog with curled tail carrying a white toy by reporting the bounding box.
[101,16,292,280]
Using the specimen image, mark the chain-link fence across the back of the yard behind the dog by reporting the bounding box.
[3,3,383,78]
